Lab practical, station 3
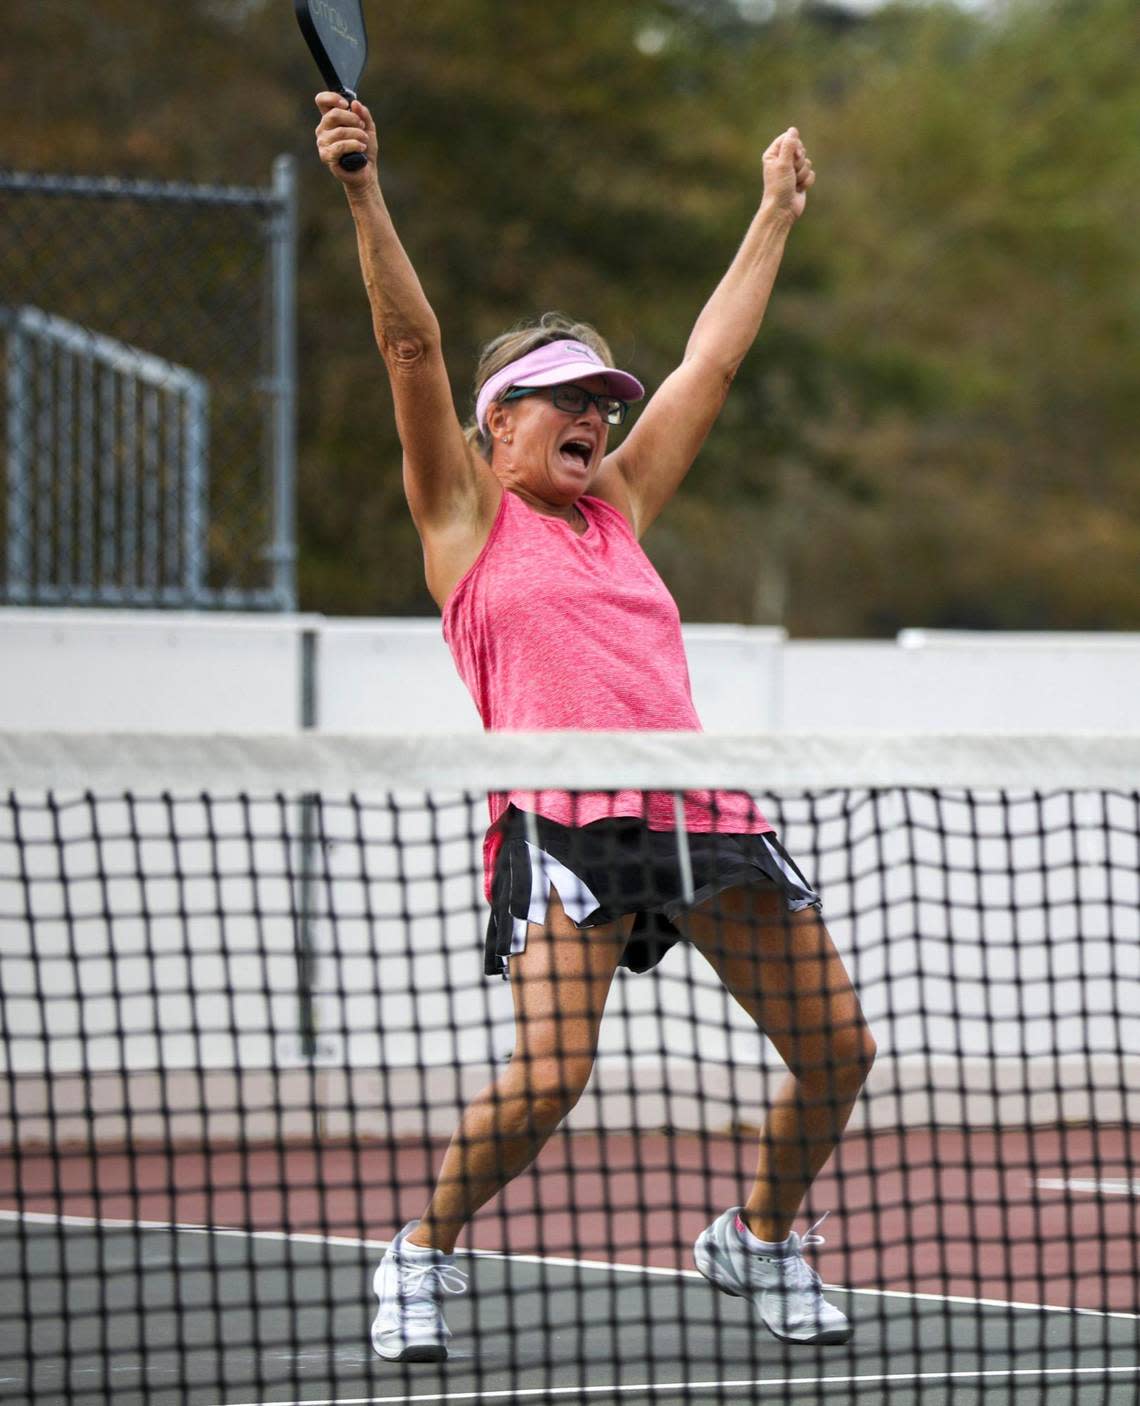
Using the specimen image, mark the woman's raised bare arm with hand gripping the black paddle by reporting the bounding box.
[316,93,493,584]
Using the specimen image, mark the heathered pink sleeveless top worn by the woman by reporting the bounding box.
[443,492,772,894]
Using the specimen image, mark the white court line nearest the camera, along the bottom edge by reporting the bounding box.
[212,1365,1140,1406]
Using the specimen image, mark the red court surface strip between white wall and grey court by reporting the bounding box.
[0,1128,1140,1313]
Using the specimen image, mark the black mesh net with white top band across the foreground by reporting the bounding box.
[0,734,1140,1406]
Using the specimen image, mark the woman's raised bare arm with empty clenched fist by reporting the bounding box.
[596,127,815,536]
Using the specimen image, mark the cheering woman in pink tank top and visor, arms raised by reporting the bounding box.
[316,93,874,1361]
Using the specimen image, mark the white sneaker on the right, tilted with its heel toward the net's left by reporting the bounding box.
[693,1206,855,1343]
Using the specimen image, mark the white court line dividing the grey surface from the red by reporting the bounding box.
[0,1209,1140,1321]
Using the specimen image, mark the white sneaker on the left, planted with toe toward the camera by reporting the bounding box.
[373,1220,467,1362]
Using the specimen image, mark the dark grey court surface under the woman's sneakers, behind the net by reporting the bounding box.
[0,1212,1140,1406]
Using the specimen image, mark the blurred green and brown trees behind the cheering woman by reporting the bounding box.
[0,0,1140,636]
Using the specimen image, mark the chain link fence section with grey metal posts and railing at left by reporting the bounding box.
[0,157,297,610]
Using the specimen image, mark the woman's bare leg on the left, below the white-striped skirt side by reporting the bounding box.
[408,893,633,1254]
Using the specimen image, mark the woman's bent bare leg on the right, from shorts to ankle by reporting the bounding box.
[683,889,874,1243]
